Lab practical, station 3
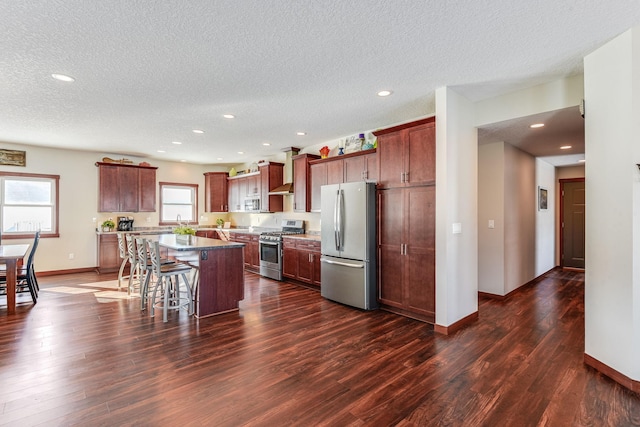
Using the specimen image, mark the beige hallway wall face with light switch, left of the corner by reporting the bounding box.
[478,142,505,295]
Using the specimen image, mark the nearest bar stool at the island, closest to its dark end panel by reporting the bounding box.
[147,241,193,322]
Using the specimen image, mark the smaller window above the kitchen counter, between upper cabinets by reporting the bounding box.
[160,182,198,225]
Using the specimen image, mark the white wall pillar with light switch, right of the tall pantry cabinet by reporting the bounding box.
[436,87,478,326]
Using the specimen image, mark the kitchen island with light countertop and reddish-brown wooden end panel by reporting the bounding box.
[151,234,244,318]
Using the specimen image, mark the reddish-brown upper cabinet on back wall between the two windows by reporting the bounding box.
[96,162,158,212]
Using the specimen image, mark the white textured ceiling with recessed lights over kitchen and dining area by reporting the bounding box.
[0,0,640,164]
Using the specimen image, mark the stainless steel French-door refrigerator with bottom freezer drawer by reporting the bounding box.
[320,182,378,310]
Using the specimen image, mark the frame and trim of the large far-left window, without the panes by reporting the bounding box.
[0,172,60,240]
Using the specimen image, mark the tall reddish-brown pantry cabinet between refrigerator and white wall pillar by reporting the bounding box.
[374,117,436,323]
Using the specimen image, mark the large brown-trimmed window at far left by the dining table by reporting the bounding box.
[0,172,60,238]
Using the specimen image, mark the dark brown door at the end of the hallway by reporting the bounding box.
[560,178,585,268]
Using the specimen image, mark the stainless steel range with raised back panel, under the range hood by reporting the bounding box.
[259,219,304,280]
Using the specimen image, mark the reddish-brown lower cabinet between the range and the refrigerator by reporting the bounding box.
[282,237,320,287]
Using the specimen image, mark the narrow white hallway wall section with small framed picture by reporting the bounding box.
[534,159,559,277]
